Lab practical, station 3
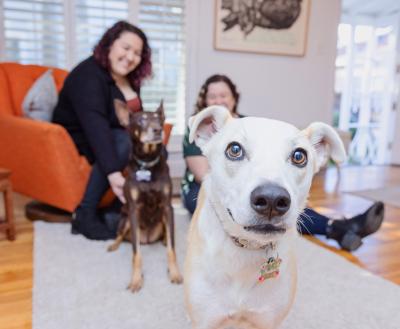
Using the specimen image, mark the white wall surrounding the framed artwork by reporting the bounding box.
[187,0,340,126]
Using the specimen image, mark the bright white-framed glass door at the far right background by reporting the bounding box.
[335,17,398,165]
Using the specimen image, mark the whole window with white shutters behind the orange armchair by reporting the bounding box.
[0,0,185,134]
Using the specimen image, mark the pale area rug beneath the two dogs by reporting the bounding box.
[33,209,400,329]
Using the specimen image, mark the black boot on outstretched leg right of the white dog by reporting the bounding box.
[326,202,384,251]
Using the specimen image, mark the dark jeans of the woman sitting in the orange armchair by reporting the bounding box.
[79,129,132,209]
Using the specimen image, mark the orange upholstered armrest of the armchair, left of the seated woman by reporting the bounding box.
[0,115,90,211]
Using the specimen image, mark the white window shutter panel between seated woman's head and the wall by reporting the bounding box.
[138,0,185,134]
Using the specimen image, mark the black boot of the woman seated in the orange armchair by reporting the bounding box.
[71,207,115,240]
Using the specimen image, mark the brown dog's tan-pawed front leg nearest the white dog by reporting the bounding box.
[164,205,183,283]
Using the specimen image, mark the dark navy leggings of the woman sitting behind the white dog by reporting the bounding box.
[182,182,329,235]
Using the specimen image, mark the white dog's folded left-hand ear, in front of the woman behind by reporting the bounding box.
[189,105,232,148]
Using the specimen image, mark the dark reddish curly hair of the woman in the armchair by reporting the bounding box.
[93,21,152,91]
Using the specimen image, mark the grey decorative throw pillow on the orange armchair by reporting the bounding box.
[22,69,58,121]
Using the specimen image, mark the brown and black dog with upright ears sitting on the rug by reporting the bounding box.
[108,100,182,292]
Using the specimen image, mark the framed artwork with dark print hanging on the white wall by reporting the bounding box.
[214,0,311,56]
